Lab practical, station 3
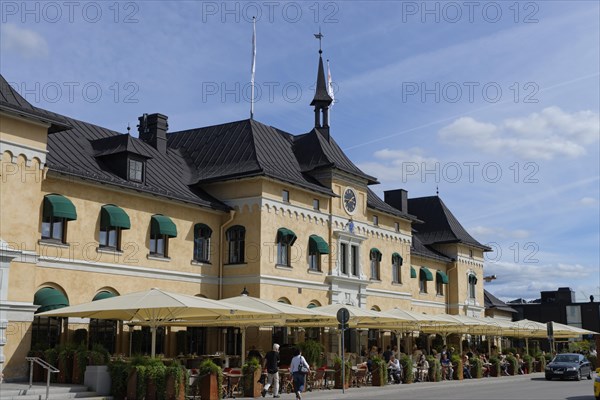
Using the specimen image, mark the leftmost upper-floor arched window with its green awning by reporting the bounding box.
[42,194,77,243]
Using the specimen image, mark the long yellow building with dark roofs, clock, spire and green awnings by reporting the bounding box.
[0,55,489,379]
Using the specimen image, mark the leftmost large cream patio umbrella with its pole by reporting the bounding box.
[37,288,264,357]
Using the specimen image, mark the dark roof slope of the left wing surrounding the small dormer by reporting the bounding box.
[46,117,230,211]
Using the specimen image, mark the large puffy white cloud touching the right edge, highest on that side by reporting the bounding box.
[439,107,600,160]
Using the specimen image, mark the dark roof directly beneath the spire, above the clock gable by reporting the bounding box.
[291,128,379,184]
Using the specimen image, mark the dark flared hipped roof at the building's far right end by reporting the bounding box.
[408,196,491,251]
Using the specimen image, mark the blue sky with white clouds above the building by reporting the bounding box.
[0,0,600,300]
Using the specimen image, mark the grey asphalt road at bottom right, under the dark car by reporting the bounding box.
[267,373,594,400]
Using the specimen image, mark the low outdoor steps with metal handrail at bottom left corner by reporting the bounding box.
[0,383,113,400]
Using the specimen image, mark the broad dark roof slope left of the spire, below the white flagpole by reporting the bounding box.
[167,119,334,196]
